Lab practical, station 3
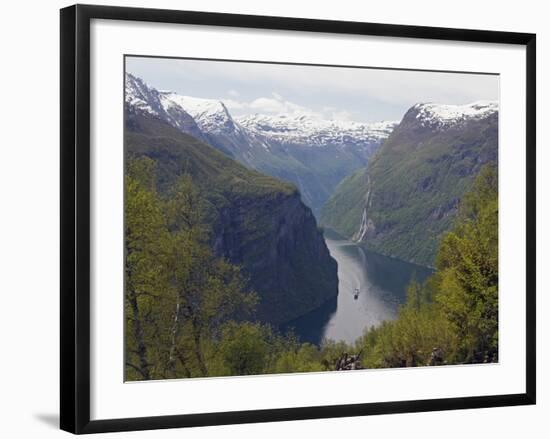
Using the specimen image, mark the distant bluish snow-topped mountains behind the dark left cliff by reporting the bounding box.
[126,74,396,214]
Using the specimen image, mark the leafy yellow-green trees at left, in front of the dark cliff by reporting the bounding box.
[125,162,257,379]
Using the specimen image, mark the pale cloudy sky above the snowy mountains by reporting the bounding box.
[126,57,499,122]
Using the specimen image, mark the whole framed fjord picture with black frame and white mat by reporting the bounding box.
[61,5,536,433]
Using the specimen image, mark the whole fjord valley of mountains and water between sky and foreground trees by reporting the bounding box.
[125,74,498,344]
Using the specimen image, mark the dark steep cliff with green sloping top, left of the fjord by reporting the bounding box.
[125,108,338,325]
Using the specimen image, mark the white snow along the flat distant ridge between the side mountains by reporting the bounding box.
[237,114,398,150]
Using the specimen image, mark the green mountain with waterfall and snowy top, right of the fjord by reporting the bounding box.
[320,102,498,266]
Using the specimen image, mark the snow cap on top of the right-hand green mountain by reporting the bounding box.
[412,101,498,128]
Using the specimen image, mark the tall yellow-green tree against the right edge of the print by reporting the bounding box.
[435,166,498,362]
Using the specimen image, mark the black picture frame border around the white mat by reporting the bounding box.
[60,5,536,434]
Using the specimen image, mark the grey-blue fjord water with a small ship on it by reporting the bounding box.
[282,230,432,344]
